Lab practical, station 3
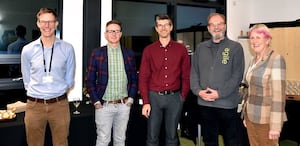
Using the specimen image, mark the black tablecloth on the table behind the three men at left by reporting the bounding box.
[0,103,147,146]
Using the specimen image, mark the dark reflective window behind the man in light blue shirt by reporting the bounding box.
[0,0,62,108]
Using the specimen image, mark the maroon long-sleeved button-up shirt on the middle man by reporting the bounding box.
[139,40,190,104]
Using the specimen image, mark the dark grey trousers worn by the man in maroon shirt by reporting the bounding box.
[147,91,183,146]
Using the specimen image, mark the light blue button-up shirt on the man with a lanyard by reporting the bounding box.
[21,39,75,99]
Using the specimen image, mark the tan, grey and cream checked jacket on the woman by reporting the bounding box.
[244,49,287,131]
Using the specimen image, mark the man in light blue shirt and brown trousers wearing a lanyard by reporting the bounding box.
[21,8,75,146]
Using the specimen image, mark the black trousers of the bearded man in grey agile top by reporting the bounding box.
[198,106,242,146]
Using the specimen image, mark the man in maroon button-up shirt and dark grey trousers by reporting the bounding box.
[139,14,190,146]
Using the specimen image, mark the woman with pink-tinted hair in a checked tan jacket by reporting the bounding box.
[243,24,287,146]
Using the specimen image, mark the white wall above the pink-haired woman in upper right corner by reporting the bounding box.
[227,0,300,40]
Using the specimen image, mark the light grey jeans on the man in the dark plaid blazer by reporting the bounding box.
[95,103,130,146]
